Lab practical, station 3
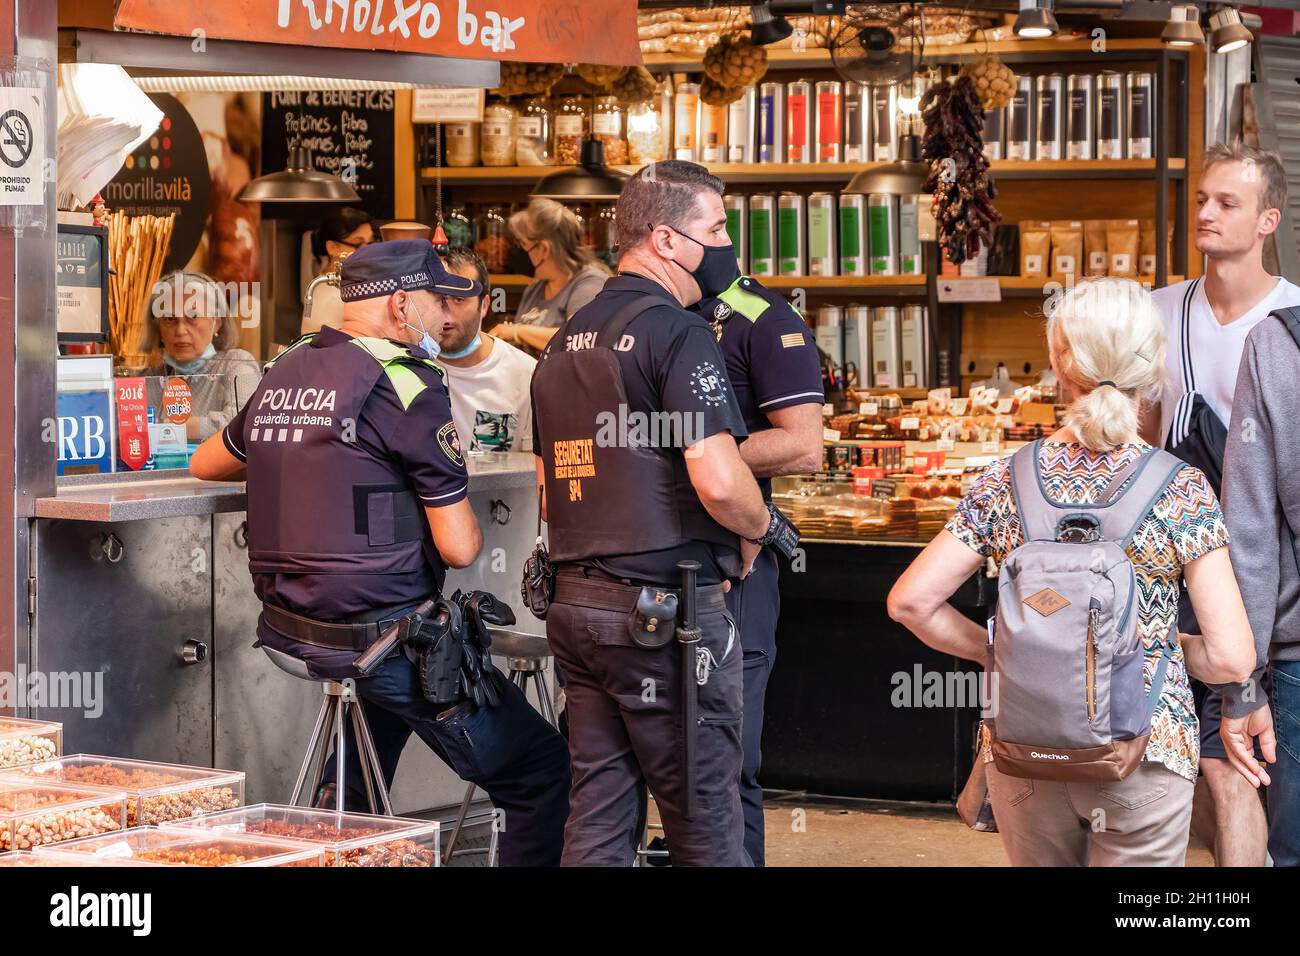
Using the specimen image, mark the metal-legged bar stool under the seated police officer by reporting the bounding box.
[263,645,393,817]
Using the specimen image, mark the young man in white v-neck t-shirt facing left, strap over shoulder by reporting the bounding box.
[1143,143,1300,866]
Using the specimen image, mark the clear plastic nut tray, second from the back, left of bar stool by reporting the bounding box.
[0,753,244,826]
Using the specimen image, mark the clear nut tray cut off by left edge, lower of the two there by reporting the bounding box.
[0,780,126,853]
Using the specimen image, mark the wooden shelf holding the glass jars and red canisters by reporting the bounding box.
[420,157,1187,189]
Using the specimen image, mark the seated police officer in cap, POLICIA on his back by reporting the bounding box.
[190,241,568,865]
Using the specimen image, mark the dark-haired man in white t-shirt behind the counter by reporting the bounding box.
[430,248,537,453]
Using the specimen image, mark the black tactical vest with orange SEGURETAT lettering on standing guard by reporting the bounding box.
[532,295,737,562]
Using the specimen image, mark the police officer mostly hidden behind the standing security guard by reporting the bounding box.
[694,268,826,866]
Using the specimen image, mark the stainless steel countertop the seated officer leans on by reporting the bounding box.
[36,451,536,522]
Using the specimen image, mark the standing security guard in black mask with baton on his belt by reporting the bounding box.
[533,161,772,865]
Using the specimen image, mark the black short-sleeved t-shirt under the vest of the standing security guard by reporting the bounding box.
[533,273,748,587]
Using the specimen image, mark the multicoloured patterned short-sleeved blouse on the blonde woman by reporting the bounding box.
[948,442,1227,780]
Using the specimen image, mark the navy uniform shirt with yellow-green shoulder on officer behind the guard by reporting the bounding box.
[692,276,826,501]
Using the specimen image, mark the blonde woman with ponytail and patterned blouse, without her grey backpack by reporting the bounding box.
[889,278,1255,866]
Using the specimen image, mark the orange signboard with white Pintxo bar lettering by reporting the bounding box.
[113,0,641,65]
